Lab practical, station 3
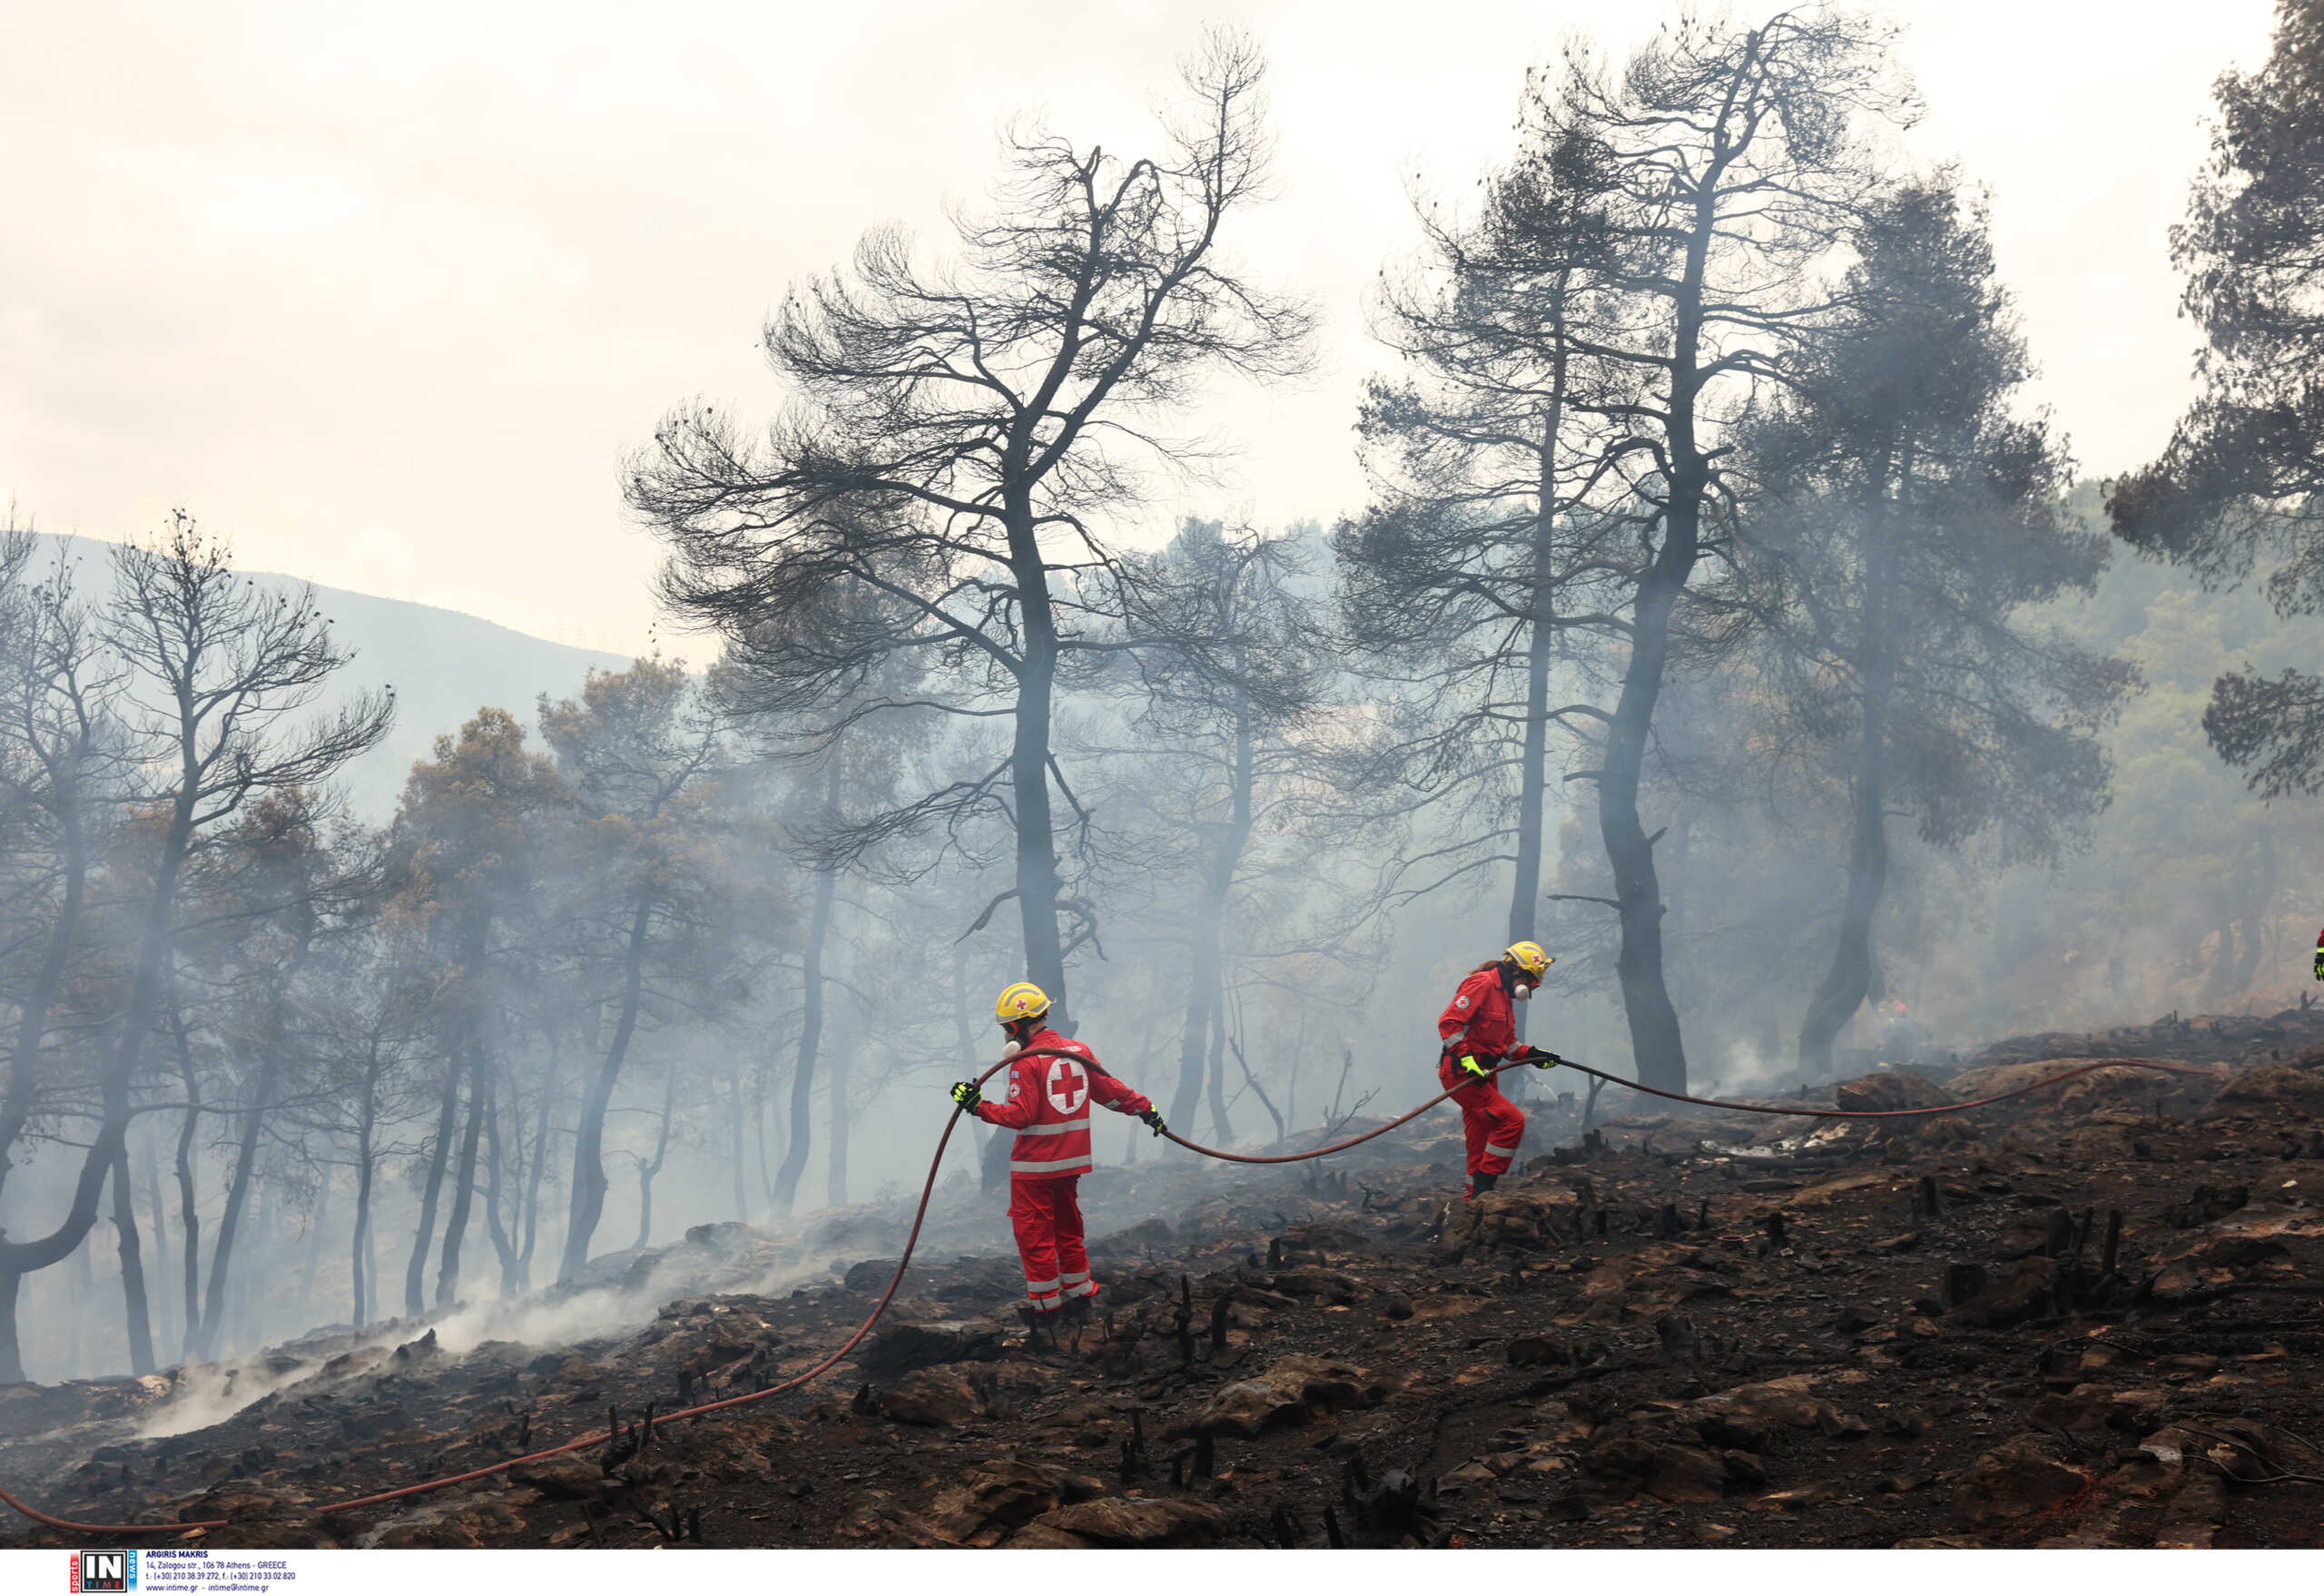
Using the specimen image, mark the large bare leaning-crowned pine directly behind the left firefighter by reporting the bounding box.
[627,34,1308,1022]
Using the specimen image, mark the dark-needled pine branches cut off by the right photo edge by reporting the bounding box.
[2108,0,2324,797]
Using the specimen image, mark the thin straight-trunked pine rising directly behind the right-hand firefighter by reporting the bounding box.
[1334,122,1624,1031]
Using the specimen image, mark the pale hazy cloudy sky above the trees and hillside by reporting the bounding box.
[0,0,2269,653]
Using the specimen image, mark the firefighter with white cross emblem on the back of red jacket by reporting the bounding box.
[953,980,1162,1315]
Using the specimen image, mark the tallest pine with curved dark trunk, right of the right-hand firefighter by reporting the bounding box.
[1529,9,1910,1088]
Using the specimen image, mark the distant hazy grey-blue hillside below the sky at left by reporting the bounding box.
[22,535,630,823]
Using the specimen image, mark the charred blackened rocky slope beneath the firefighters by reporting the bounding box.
[0,1009,2324,1547]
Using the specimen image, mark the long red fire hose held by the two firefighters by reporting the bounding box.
[0,1048,2212,1535]
